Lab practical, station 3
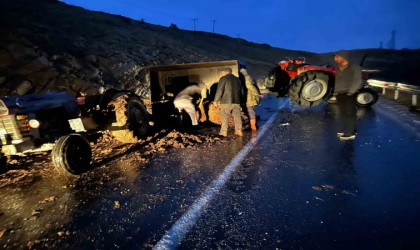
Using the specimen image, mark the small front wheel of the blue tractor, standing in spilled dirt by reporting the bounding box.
[51,134,92,175]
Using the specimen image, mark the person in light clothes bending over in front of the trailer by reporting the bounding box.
[174,84,206,126]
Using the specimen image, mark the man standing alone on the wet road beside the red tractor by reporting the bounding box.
[334,50,362,140]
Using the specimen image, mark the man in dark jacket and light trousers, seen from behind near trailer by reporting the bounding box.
[214,67,244,136]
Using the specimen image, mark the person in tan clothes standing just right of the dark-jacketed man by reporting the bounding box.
[239,69,261,131]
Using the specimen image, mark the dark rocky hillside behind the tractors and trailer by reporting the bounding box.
[0,0,420,96]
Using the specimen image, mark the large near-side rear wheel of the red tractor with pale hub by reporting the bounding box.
[289,71,333,108]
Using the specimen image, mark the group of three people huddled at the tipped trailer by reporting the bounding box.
[174,67,262,137]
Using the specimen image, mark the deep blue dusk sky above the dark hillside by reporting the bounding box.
[63,0,420,52]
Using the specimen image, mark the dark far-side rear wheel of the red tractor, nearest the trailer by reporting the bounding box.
[265,66,290,97]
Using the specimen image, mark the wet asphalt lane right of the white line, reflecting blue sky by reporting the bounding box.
[181,98,420,249]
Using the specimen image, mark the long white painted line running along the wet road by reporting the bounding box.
[153,102,286,250]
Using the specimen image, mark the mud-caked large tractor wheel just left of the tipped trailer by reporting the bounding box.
[108,95,149,143]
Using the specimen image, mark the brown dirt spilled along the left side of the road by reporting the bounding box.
[0,127,233,249]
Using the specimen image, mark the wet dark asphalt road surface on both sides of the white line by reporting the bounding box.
[0,95,420,249]
